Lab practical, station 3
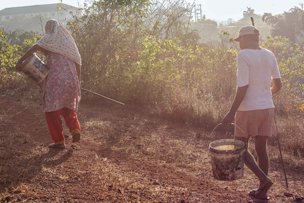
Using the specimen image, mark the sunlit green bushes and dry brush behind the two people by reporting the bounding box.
[0,0,304,125]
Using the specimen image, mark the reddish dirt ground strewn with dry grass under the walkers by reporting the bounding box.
[0,92,304,203]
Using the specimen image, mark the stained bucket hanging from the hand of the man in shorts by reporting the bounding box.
[209,139,245,181]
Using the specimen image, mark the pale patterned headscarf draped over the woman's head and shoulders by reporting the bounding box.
[37,20,81,65]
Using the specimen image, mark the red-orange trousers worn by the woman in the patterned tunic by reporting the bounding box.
[45,108,80,144]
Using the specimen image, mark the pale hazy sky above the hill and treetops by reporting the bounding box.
[0,0,304,21]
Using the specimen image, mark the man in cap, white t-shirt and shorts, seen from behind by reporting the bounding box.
[222,26,282,199]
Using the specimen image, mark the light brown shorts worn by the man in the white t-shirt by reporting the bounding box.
[234,108,275,138]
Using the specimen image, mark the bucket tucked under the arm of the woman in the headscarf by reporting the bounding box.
[21,53,49,83]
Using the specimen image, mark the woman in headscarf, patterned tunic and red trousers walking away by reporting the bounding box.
[16,20,81,149]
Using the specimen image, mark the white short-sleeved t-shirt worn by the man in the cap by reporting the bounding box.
[237,48,281,111]
